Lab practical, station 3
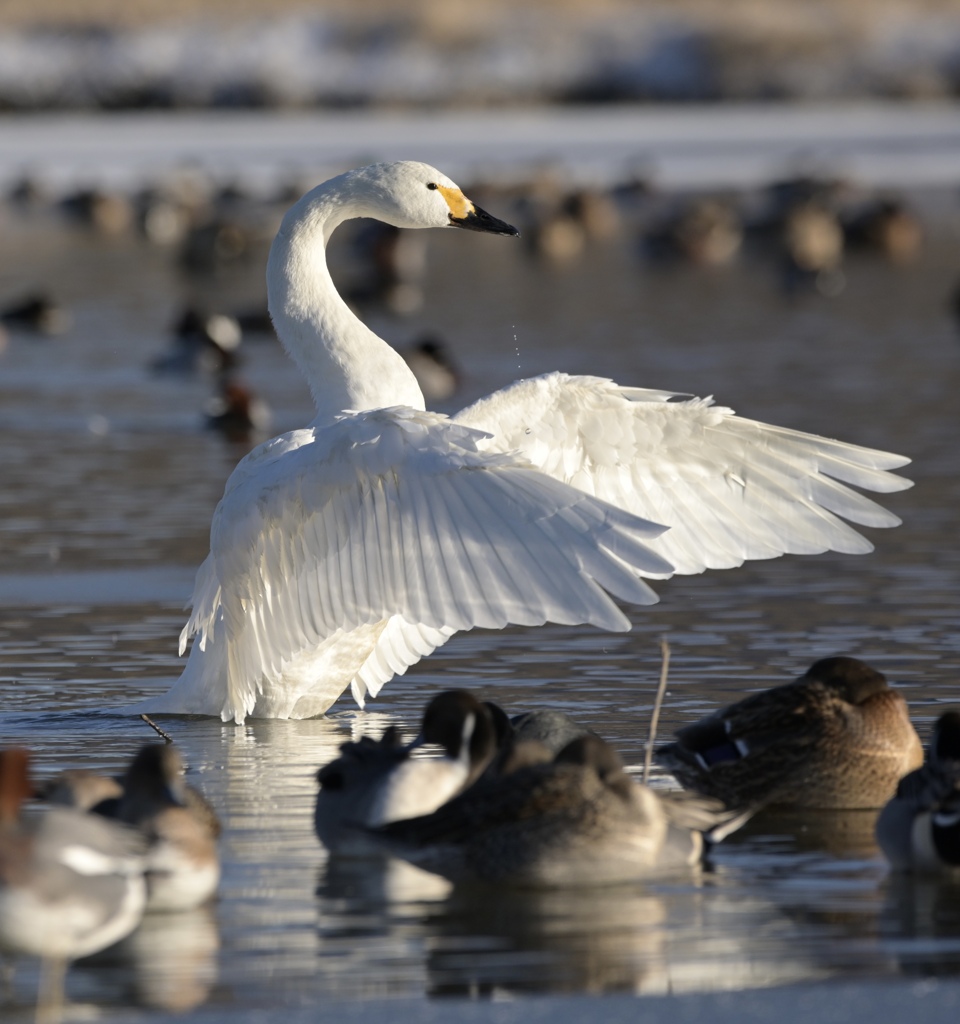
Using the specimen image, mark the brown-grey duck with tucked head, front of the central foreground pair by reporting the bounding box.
[366,735,748,888]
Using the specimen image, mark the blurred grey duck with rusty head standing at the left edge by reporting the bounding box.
[0,748,146,1020]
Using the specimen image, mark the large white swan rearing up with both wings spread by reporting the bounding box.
[136,162,910,723]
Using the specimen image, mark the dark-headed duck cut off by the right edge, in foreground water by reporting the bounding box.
[876,710,960,876]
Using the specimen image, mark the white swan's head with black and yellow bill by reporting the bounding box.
[342,160,520,234]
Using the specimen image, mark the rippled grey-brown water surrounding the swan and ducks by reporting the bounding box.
[0,193,960,1021]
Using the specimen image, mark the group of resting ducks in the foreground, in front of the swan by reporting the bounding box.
[0,657,960,1020]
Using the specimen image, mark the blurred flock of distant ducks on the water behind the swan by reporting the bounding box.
[0,166,941,441]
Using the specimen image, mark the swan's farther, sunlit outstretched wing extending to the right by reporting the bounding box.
[455,374,911,573]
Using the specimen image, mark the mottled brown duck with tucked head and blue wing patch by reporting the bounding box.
[656,656,923,810]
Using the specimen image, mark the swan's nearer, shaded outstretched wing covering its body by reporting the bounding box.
[181,409,672,714]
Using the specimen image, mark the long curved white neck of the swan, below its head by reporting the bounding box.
[267,174,425,423]
